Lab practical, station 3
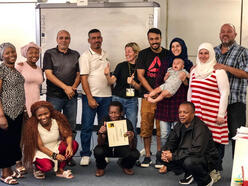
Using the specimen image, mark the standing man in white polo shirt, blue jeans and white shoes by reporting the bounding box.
[79,29,112,165]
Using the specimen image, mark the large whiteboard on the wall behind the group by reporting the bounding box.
[36,2,159,70]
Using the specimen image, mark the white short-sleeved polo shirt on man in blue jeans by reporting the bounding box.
[79,48,112,97]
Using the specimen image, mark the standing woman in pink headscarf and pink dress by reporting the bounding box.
[16,42,43,117]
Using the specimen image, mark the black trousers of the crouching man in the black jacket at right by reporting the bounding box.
[156,152,211,186]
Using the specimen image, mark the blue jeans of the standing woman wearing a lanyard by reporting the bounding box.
[112,96,138,134]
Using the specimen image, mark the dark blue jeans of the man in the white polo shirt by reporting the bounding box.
[80,95,112,156]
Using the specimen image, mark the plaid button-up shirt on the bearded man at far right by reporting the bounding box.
[214,42,248,104]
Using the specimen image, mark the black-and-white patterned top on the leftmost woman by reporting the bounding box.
[0,63,25,119]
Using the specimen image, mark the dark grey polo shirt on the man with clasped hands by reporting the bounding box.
[43,48,80,98]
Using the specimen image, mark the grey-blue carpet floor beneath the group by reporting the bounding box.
[0,134,232,186]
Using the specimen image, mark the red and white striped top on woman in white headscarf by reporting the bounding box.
[188,71,229,144]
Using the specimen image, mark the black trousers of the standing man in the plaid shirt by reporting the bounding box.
[227,102,246,155]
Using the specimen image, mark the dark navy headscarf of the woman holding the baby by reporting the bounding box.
[169,37,193,72]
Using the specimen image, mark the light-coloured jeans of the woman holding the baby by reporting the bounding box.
[160,121,177,146]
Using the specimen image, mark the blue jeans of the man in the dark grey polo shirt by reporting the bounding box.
[46,96,77,137]
